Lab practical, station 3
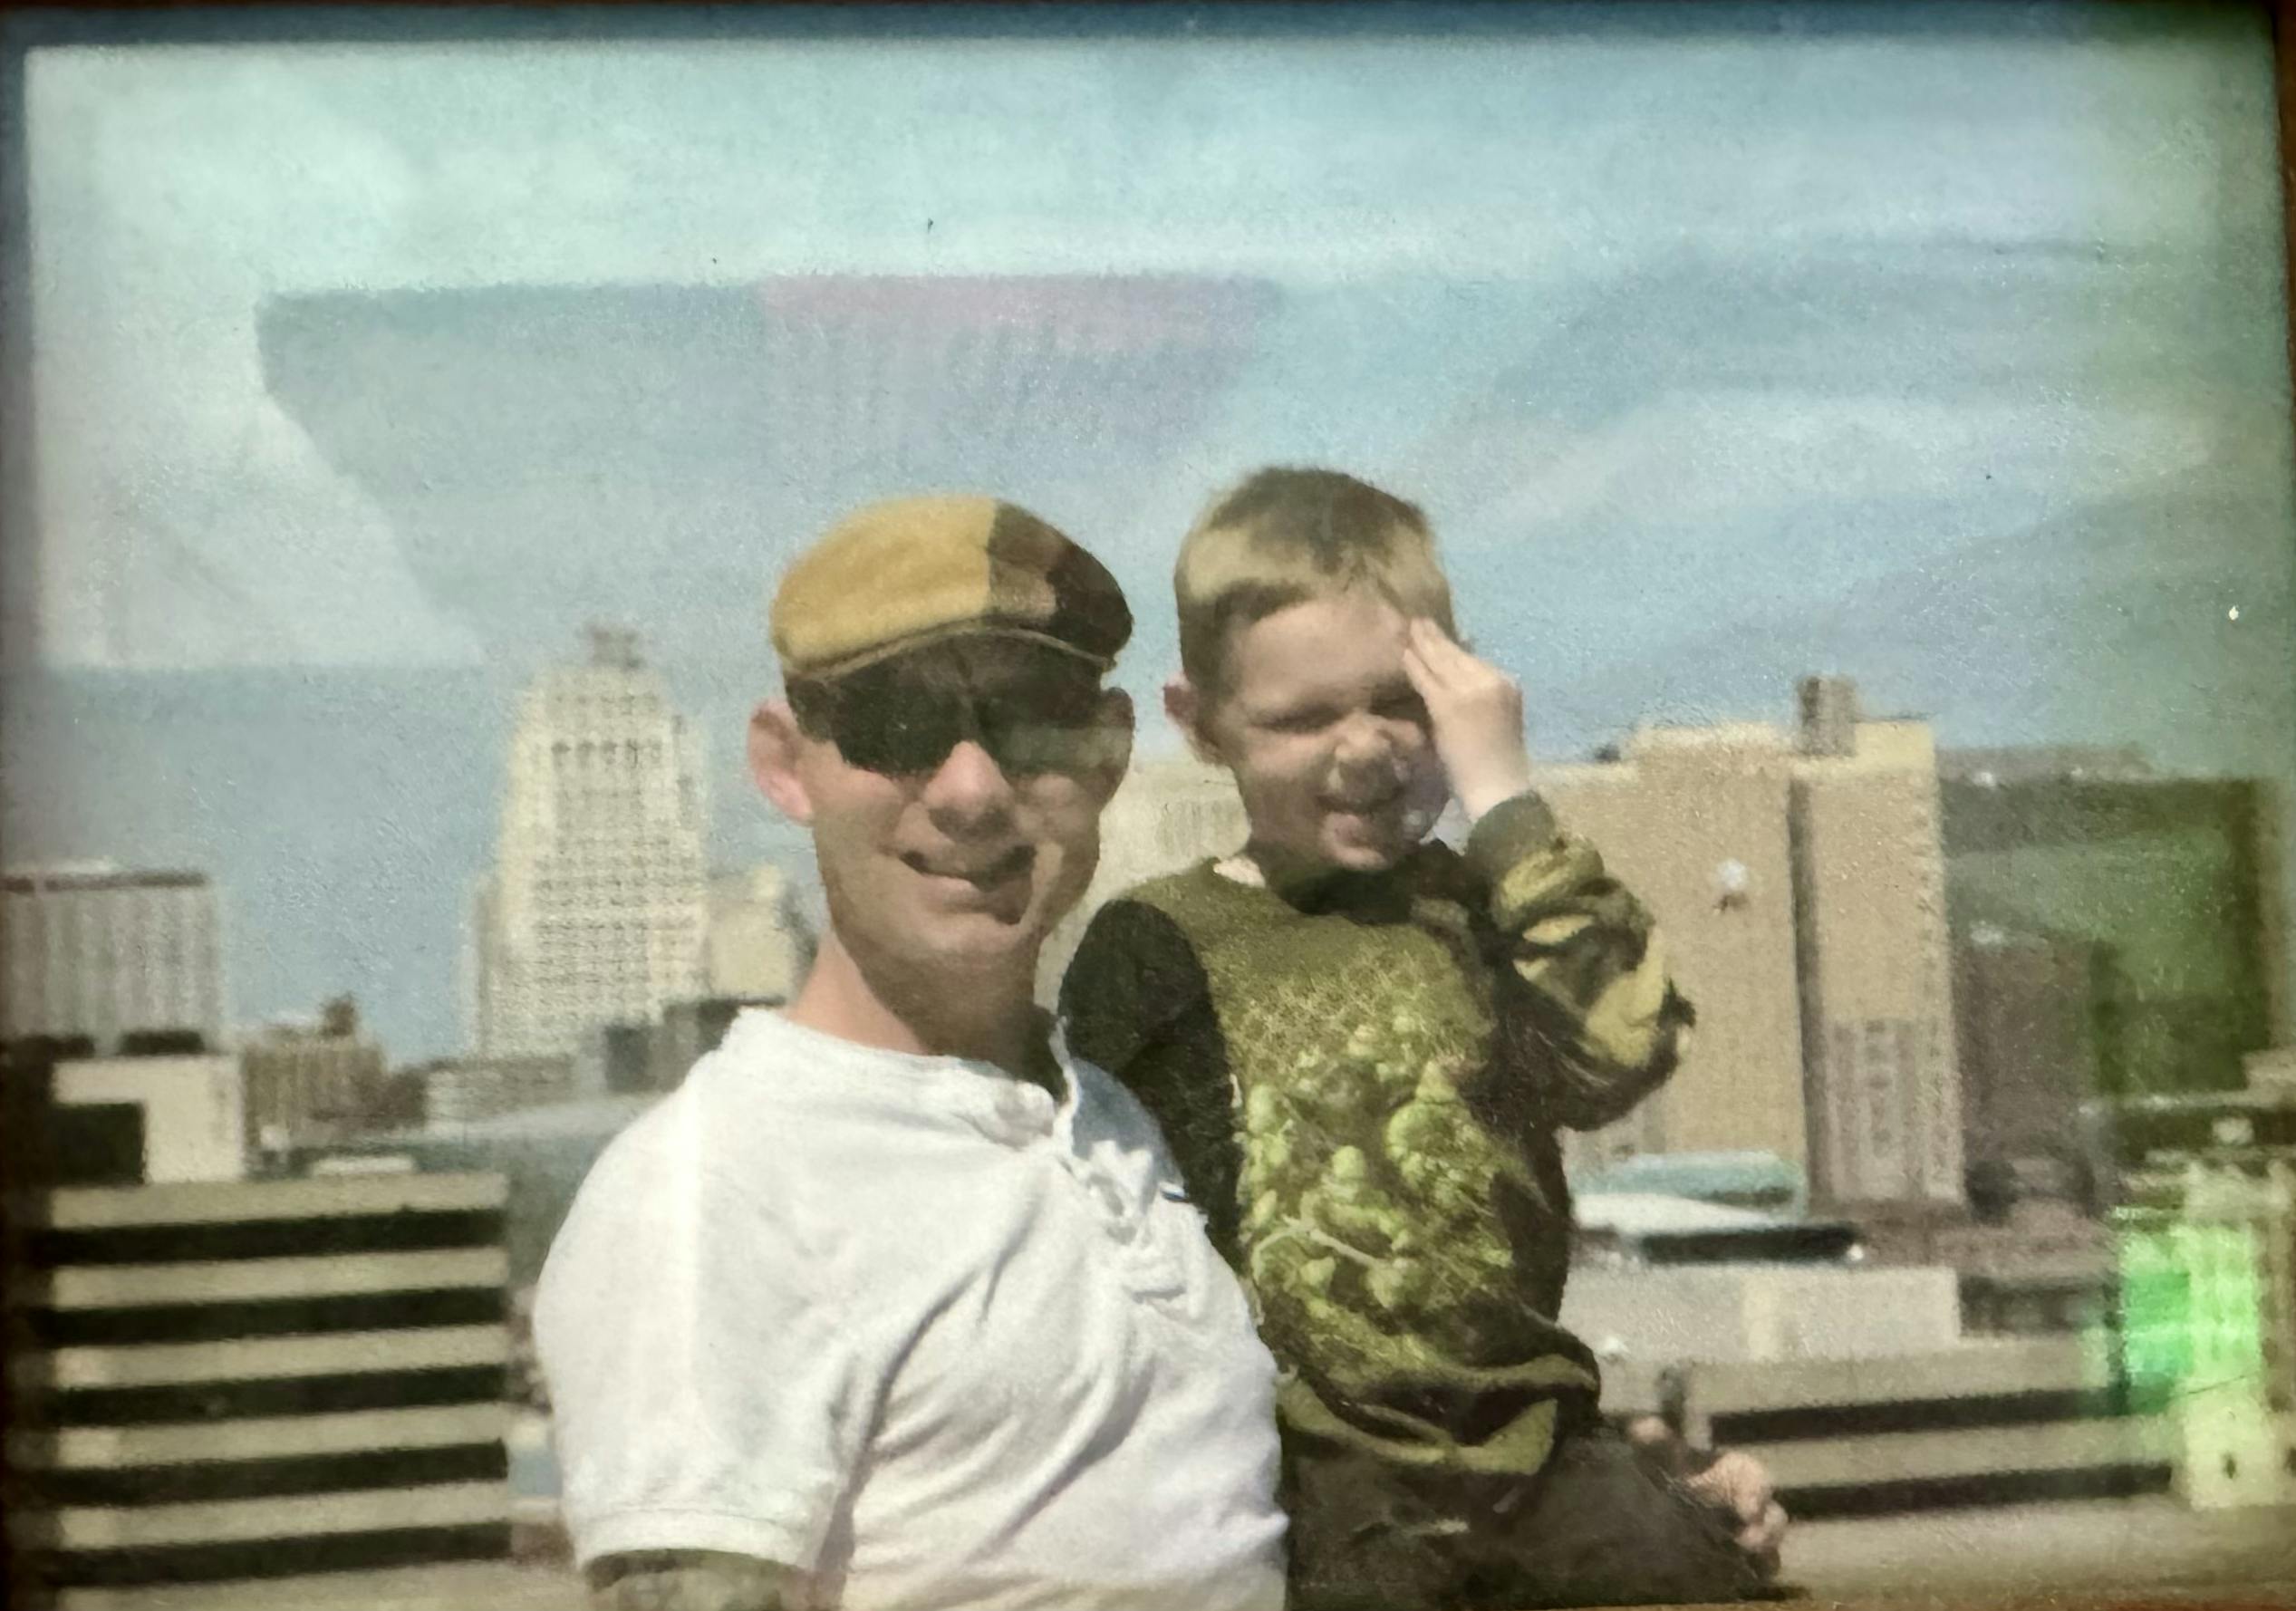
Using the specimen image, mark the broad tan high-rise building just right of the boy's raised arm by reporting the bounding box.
[1539,680,1963,1207]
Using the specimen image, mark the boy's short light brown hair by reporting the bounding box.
[1171,468,1451,693]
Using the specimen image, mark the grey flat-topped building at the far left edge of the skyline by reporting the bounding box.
[0,863,227,1048]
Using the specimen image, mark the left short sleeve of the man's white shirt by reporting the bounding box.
[535,1104,874,1569]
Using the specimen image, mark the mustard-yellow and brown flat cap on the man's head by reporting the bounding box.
[771,496,1132,677]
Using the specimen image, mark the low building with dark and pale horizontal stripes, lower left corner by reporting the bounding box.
[7,1175,510,1590]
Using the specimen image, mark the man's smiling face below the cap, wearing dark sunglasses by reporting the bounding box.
[776,638,1130,982]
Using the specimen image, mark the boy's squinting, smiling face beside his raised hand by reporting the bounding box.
[1173,587,1449,874]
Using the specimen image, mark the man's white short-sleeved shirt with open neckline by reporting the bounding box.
[535,1009,1284,1611]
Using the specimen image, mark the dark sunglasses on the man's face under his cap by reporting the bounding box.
[790,677,1114,778]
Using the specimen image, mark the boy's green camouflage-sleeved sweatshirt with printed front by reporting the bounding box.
[1061,794,1690,1473]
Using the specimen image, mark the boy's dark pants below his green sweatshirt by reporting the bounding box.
[1286,1423,1766,1611]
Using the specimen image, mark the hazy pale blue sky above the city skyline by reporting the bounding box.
[0,5,2296,1060]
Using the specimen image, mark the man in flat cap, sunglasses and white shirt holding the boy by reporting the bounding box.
[535,498,1284,1611]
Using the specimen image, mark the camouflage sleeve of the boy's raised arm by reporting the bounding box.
[1467,792,1694,1129]
